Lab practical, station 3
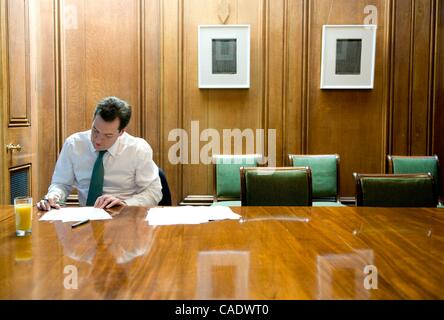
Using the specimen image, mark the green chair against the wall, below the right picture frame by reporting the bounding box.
[288,154,340,201]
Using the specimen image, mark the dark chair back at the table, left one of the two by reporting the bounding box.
[240,167,312,206]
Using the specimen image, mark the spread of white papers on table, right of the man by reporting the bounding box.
[145,206,240,226]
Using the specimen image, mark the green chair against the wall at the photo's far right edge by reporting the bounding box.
[387,155,443,208]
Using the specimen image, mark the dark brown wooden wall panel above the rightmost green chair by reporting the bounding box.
[389,0,435,155]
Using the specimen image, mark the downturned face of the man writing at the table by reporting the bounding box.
[91,115,125,151]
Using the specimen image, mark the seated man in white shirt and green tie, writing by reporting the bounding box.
[37,97,162,210]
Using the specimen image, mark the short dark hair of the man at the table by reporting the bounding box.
[94,97,131,131]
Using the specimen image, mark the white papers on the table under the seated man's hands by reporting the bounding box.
[39,207,112,222]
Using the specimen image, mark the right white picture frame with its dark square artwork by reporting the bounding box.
[321,25,377,89]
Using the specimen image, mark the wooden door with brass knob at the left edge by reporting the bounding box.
[0,0,37,204]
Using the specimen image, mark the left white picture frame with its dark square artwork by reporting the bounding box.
[198,25,250,89]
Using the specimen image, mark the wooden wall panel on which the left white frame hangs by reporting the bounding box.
[182,0,265,195]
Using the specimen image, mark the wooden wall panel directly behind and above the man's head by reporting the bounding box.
[60,0,141,138]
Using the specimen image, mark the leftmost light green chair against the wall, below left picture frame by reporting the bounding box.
[213,154,263,201]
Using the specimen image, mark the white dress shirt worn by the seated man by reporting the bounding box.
[48,130,162,206]
